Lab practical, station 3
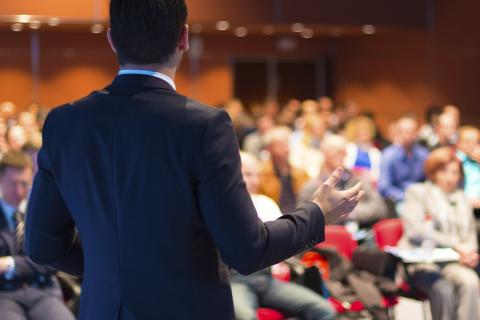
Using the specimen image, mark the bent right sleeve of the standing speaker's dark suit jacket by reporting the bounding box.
[196,111,325,274]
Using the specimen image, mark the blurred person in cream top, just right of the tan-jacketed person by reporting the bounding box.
[290,113,328,178]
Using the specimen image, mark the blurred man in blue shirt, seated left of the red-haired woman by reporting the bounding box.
[378,116,428,210]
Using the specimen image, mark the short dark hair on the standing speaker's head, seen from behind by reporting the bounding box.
[110,0,187,65]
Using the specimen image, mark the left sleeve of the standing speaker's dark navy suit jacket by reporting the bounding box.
[25,114,83,275]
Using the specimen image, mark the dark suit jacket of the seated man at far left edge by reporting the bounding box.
[0,200,52,287]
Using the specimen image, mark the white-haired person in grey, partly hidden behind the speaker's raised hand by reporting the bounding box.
[298,135,387,227]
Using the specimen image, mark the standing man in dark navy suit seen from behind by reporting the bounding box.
[26,0,361,320]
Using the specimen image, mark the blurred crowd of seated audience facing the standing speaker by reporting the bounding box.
[0,97,480,319]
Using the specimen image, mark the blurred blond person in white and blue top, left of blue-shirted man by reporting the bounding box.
[345,116,382,184]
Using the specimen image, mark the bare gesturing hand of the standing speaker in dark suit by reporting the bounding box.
[313,168,363,224]
